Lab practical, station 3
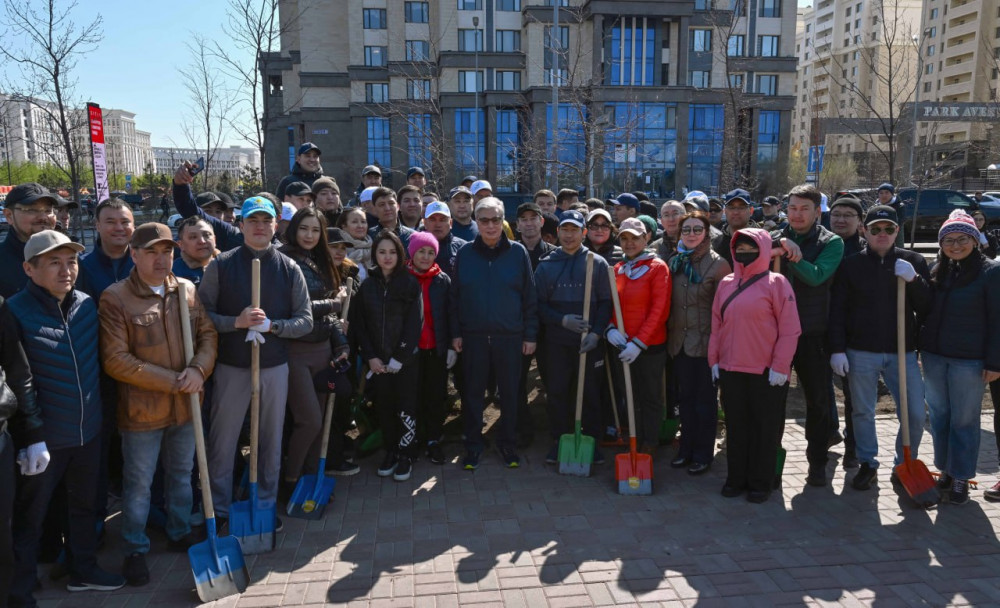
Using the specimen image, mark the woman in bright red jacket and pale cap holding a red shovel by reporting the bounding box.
[607,218,670,456]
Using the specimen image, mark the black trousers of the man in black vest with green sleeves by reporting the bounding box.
[779,334,832,466]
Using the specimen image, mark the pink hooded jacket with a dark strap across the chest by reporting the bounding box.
[708,228,802,374]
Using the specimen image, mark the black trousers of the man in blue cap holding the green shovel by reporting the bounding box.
[545,342,604,441]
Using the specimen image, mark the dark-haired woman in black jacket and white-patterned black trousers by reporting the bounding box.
[349,230,423,481]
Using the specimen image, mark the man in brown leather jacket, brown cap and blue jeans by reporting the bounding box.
[99,223,218,586]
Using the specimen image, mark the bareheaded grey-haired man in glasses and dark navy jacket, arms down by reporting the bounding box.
[451,197,538,471]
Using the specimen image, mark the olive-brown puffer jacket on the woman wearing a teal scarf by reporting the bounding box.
[667,237,732,357]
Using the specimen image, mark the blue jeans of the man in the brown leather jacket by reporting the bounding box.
[122,423,194,553]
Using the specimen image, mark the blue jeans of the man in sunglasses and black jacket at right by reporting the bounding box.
[847,348,927,467]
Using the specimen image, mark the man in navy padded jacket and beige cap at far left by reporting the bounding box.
[4,230,125,606]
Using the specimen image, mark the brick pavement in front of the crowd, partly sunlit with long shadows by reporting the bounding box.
[29,412,1000,608]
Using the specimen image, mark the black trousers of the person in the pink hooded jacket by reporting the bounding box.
[719,370,785,492]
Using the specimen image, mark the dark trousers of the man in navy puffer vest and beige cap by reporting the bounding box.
[10,437,101,605]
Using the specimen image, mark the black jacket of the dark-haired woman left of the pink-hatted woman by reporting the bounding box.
[348,265,424,365]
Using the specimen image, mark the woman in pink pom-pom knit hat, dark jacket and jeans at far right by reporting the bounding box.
[920,211,1000,504]
